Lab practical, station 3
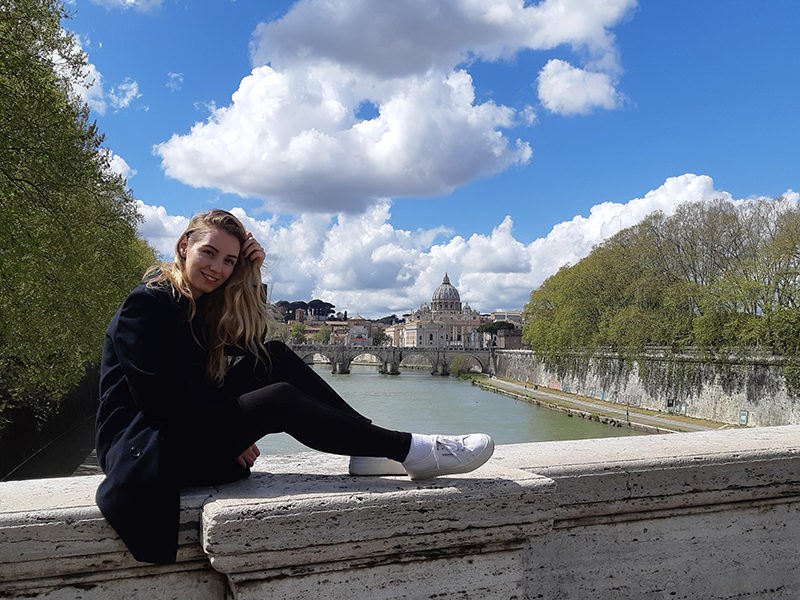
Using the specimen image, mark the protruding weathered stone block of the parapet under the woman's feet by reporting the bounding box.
[203,465,554,573]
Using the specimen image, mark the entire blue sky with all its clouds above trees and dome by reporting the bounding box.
[65,0,800,317]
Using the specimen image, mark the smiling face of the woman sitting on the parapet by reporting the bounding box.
[178,228,242,299]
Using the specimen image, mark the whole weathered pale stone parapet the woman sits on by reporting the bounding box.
[0,426,800,600]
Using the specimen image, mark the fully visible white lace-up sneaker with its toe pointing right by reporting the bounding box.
[403,433,494,479]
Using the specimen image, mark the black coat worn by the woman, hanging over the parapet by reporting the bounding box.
[96,285,249,563]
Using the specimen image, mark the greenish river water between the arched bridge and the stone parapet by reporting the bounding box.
[258,365,641,454]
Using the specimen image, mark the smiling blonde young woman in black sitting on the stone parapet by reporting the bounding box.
[96,210,494,563]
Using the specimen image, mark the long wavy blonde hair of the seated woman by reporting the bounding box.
[146,209,269,385]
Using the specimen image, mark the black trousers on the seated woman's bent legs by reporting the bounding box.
[220,342,411,462]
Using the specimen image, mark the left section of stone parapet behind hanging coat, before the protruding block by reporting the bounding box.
[0,476,225,600]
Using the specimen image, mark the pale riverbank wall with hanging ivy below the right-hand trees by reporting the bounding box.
[495,350,800,426]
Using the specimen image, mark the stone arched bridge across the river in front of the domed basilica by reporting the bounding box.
[289,344,495,375]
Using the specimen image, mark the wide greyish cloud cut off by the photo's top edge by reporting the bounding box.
[251,0,636,79]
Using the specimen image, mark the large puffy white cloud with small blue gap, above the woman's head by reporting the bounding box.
[156,66,531,213]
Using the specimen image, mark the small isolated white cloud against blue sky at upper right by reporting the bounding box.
[537,59,624,115]
